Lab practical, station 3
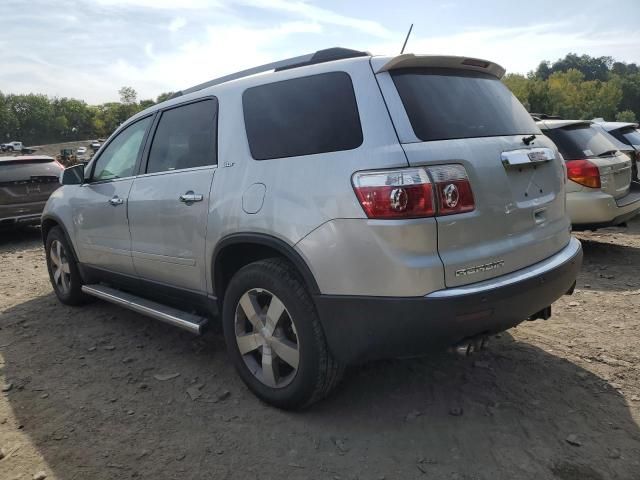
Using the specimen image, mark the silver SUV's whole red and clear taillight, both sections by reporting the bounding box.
[353,165,475,219]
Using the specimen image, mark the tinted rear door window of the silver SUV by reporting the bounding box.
[147,100,218,173]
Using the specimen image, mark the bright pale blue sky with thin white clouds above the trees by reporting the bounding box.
[0,0,640,104]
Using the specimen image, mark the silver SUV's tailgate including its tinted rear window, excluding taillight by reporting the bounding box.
[377,62,570,287]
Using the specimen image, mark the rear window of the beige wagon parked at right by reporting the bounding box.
[544,124,618,160]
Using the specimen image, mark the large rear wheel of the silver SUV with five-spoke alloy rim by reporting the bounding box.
[222,258,344,409]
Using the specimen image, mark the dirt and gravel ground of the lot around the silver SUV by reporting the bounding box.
[0,221,640,480]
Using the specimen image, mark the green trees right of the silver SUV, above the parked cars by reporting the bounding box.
[504,53,640,122]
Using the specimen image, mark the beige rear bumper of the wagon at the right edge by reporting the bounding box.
[567,189,640,229]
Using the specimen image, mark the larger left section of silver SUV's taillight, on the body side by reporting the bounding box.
[353,168,435,219]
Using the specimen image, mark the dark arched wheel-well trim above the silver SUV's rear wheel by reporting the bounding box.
[211,233,320,302]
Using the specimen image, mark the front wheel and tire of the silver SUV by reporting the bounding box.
[45,227,92,305]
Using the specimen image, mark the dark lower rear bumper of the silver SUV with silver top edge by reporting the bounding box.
[315,238,582,364]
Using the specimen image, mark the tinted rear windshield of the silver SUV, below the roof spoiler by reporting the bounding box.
[391,68,540,142]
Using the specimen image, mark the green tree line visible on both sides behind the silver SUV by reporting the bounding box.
[0,53,640,145]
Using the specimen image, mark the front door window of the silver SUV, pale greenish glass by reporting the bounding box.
[92,117,152,182]
